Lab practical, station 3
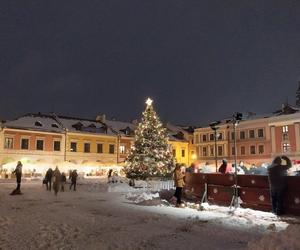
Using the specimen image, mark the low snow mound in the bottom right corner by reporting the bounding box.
[248,225,300,250]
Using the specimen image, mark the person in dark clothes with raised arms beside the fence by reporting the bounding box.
[268,155,292,215]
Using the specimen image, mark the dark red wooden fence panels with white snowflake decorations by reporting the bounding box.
[184,173,300,215]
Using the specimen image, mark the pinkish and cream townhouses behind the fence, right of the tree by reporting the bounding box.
[194,104,300,165]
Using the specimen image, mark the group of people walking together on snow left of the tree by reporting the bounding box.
[43,167,78,195]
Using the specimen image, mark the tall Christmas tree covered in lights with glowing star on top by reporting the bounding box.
[125,98,174,180]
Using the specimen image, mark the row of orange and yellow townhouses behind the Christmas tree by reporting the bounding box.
[0,113,194,173]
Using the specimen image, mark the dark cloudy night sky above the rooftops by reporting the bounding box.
[0,0,300,125]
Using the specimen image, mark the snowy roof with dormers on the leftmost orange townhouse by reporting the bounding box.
[2,114,63,133]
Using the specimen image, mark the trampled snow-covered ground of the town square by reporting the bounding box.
[0,179,300,249]
